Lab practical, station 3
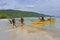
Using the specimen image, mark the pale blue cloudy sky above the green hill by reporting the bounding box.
[0,0,60,16]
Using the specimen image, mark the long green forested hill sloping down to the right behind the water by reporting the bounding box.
[0,10,49,18]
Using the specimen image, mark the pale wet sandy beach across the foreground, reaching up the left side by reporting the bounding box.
[0,19,60,40]
